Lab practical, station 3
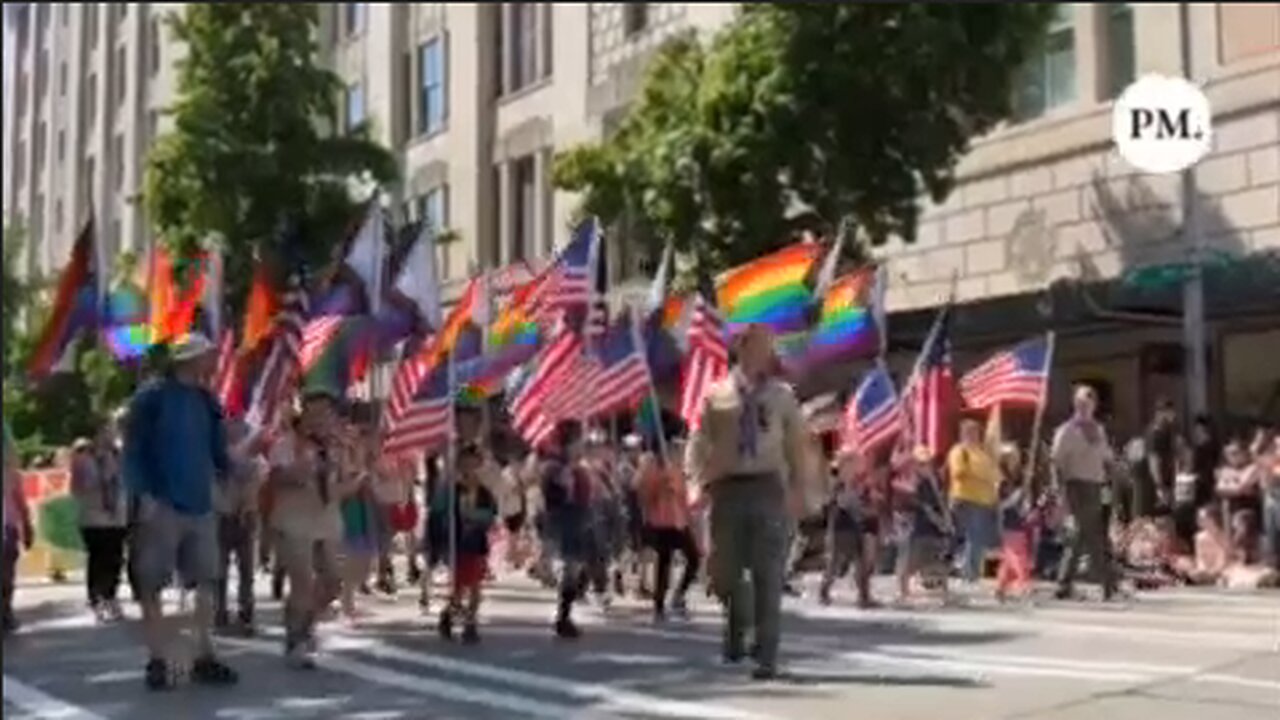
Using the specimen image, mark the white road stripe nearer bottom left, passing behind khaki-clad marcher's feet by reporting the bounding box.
[216,638,607,720]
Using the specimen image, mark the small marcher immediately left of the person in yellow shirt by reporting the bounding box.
[897,446,952,605]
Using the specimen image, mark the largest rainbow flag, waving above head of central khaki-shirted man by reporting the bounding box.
[716,241,824,333]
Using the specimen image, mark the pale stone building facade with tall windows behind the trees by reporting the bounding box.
[4,3,1280,425]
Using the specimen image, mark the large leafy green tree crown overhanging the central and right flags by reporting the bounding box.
[554,3,1053,269]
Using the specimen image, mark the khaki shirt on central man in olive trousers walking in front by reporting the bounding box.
[685,372,810,499]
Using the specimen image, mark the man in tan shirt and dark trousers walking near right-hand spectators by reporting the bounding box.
[1050,386,1117,600]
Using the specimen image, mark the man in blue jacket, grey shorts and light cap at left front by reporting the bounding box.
[124,333,238,689]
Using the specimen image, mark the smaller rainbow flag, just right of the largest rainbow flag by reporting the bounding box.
[805,268,879,364]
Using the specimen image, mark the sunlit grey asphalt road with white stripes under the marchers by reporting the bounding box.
[3,566,1280,720]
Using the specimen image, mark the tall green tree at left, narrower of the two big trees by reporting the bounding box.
[143,3,397,311]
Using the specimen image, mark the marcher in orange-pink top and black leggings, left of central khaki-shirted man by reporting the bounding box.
[639,445,701,623]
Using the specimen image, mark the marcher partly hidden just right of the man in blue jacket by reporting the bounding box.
[214,420,266,635]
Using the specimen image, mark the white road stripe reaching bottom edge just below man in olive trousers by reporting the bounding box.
[314,627,769,720]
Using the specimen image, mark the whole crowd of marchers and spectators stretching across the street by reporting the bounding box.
[4,325,1280,689]
